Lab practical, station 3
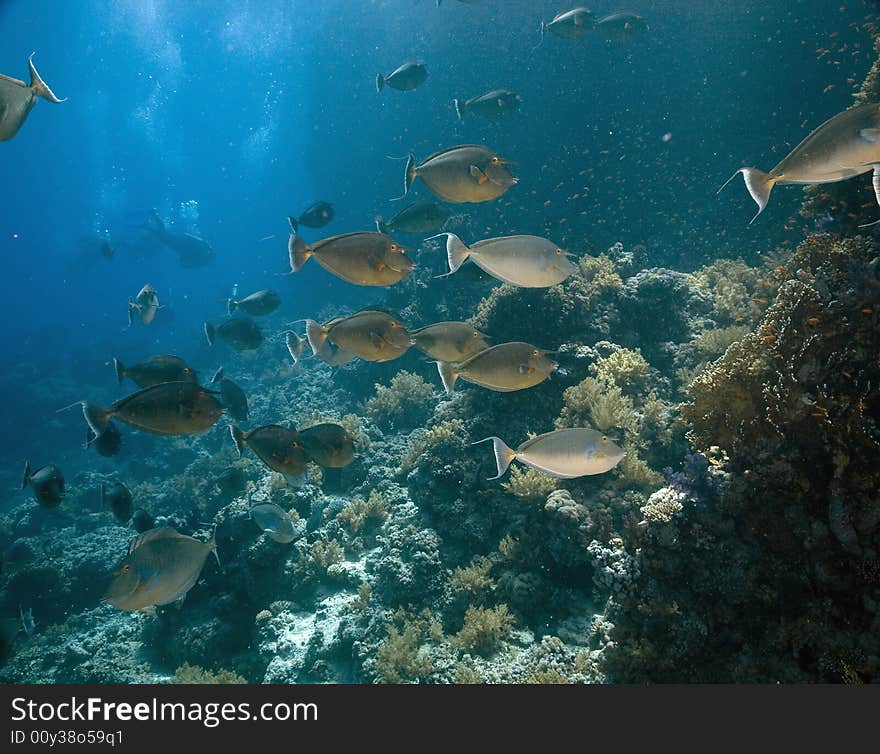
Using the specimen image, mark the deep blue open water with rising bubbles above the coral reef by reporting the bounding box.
[0,0,876,482]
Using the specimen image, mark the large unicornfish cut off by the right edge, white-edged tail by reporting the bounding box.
[718,103,880,227]
